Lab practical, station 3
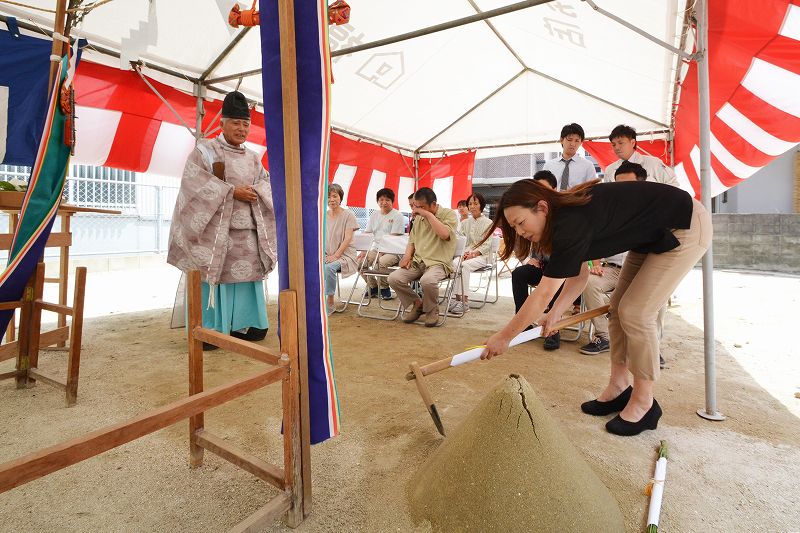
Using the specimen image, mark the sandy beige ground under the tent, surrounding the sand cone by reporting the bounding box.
[0,262,800,532]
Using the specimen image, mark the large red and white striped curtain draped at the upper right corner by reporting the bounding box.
[675,0,800,197]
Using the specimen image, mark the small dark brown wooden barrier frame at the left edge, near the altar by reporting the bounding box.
[0,263,86,407]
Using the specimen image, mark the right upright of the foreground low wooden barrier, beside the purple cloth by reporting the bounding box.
[279,290,307,528]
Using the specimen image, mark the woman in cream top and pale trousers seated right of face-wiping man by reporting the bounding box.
[448,192,492,314]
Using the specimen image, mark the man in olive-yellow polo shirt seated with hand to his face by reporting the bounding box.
[389,187,458,328]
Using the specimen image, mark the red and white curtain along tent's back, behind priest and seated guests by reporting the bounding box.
[73,61,475,210]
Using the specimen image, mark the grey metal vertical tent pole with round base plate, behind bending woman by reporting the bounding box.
[695,0,725,420]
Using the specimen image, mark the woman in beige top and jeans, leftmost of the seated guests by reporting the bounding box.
[325,183,358,315]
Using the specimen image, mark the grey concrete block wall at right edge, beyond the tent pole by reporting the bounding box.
[713,213,800,274]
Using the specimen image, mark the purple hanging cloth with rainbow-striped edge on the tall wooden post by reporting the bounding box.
[261,0,339,444]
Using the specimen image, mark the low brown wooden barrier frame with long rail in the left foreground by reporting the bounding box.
[0,271,304,532]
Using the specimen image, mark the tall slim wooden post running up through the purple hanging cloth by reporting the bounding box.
[278,0,310,516]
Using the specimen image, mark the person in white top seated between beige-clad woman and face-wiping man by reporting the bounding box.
[358,189,405,300]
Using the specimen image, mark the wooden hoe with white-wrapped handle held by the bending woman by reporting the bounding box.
[406,305,608,436]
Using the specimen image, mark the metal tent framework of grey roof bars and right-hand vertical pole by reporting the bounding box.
[0,0,725,420]
